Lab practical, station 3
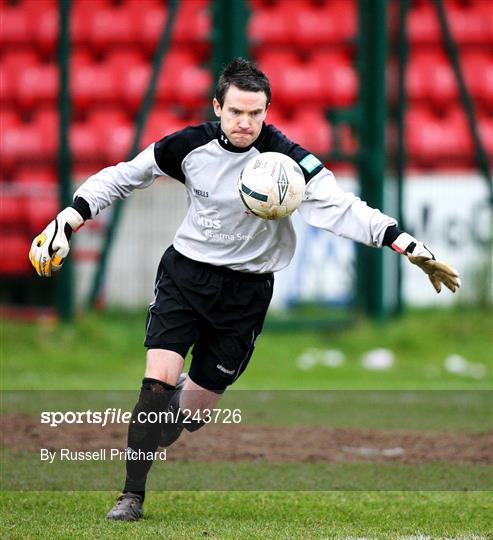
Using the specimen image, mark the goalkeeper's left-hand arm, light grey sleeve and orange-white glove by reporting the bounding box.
[29,144,165,277]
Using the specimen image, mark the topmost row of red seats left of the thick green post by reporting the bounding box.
[0,0,210,51]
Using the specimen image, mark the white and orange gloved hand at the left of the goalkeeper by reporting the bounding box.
[29,206,84,277]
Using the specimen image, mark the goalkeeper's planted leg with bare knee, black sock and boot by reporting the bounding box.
[108,349,184,521]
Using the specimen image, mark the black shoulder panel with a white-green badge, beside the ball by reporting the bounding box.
[254,124,324,183]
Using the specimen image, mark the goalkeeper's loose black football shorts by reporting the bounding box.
[144,246,274,392]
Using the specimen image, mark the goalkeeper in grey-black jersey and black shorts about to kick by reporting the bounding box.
[29,58,460,520]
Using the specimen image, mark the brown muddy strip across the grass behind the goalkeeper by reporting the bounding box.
[0,414,493,464]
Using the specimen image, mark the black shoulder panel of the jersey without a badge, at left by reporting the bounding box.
[154,122,215,183]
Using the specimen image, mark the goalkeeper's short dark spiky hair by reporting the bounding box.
[215,58,271,107]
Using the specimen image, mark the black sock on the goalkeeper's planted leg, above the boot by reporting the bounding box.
[123,378,175,498]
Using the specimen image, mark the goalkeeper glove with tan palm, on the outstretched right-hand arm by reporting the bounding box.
[392,233,461,293]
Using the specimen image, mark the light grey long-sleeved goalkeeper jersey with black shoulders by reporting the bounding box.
[74,122,396,273]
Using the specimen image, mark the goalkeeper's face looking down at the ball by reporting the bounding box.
[213,86,267,148]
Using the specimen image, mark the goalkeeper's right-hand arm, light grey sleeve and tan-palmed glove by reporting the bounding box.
[299,168,461,293]
